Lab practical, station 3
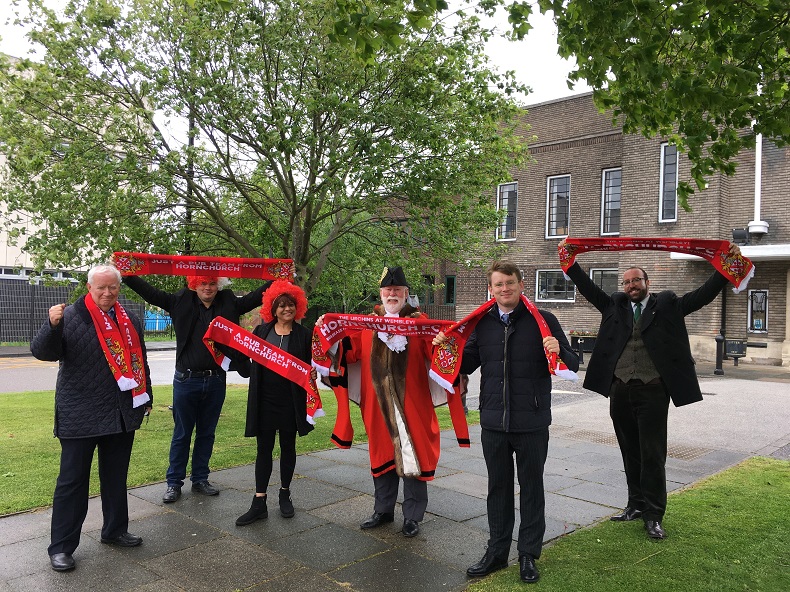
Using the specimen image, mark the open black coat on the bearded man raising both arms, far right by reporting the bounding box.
[568,263,727,407]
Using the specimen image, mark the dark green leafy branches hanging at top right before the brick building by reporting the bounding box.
[540,0,790,207]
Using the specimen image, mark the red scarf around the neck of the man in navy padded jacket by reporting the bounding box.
[431,294,578,390]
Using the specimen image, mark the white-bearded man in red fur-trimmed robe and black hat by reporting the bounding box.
[317,267,440,537]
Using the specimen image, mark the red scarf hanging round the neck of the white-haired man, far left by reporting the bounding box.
[85,294,151,407]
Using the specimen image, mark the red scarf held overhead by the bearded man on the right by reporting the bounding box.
[557,238,754,294]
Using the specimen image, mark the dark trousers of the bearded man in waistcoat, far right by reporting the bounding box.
[609,381,669,520]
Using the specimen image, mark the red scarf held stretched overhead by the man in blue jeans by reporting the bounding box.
[114,251,295,281]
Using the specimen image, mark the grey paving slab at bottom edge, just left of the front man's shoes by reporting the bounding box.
[330,549,467,592]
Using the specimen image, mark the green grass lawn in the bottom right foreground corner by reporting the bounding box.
[469,458,790,592]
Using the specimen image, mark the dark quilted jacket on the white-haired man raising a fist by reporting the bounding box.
[30,298,153,438]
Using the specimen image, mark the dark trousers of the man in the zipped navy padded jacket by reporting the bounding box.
[480,427,549,559]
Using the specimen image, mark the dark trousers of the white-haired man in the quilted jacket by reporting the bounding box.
[47,431,134,555]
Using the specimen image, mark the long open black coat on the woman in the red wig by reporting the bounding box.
[244,321,314,437]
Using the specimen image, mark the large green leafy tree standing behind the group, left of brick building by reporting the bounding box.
[0,0,526,293]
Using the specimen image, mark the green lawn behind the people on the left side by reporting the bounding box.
[0,386,470,516]
